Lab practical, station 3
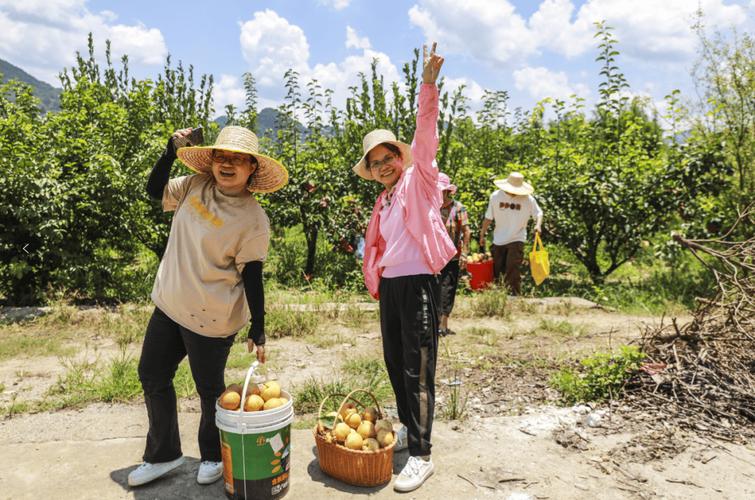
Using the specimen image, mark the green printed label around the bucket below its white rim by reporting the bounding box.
[220,425,291,499]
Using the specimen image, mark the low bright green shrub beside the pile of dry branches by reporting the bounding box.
[550,346,645,404]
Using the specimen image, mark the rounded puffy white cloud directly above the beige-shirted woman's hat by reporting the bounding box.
[241,9,309,87]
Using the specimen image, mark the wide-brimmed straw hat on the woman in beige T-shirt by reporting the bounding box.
[176,125,288,193]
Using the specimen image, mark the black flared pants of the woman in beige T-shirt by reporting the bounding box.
[139,307,235,463]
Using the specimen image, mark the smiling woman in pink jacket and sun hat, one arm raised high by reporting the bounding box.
[354,44,456,491]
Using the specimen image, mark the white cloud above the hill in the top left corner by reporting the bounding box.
[0,0,168,85]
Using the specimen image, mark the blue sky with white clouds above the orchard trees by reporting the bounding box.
[0,0,755,117]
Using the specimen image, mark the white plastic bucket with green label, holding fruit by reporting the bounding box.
[215,361,294,500]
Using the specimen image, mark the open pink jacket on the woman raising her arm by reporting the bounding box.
[362,83,456,299]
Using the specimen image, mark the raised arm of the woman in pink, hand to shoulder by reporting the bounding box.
[412,43,443,187]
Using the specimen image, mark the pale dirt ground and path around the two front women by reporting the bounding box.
[0,300,755,500]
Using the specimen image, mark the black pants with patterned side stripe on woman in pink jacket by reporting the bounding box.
[380,274,439,456]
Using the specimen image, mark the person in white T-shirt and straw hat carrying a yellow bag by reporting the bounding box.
[479,172,543,295]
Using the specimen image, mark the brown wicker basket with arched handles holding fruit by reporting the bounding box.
[314,389,395,486]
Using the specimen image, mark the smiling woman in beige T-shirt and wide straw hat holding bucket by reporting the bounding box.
[128,126,288,486]
